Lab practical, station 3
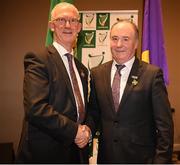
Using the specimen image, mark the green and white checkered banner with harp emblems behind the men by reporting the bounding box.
[76,10,138,69]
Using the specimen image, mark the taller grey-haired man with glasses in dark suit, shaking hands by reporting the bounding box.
[16,2,92,164]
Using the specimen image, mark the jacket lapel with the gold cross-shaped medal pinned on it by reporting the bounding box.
[119,58,142,111]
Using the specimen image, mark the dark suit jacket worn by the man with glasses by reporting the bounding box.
[16,46,88,163]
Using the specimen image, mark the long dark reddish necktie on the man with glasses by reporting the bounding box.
[66,53,85,123]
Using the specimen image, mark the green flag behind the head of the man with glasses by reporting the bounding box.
[46,0,73,46]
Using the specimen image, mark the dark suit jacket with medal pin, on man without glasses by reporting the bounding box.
[89,58,173,163]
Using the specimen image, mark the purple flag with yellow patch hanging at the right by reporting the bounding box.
[142,0,169,85]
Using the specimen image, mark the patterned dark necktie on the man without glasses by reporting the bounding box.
[112,64,125,112]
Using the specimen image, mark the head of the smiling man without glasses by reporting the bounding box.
[110,21,138,64]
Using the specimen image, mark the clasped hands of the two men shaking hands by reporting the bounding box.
[75,125,91,148]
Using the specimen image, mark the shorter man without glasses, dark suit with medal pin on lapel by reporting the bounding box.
[89,20,173,164]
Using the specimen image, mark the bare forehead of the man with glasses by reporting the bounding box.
[51,5,79,20]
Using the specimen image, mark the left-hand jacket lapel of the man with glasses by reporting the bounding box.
[48,45,76,106]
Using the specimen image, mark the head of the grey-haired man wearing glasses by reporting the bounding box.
[49,3,81,52]
